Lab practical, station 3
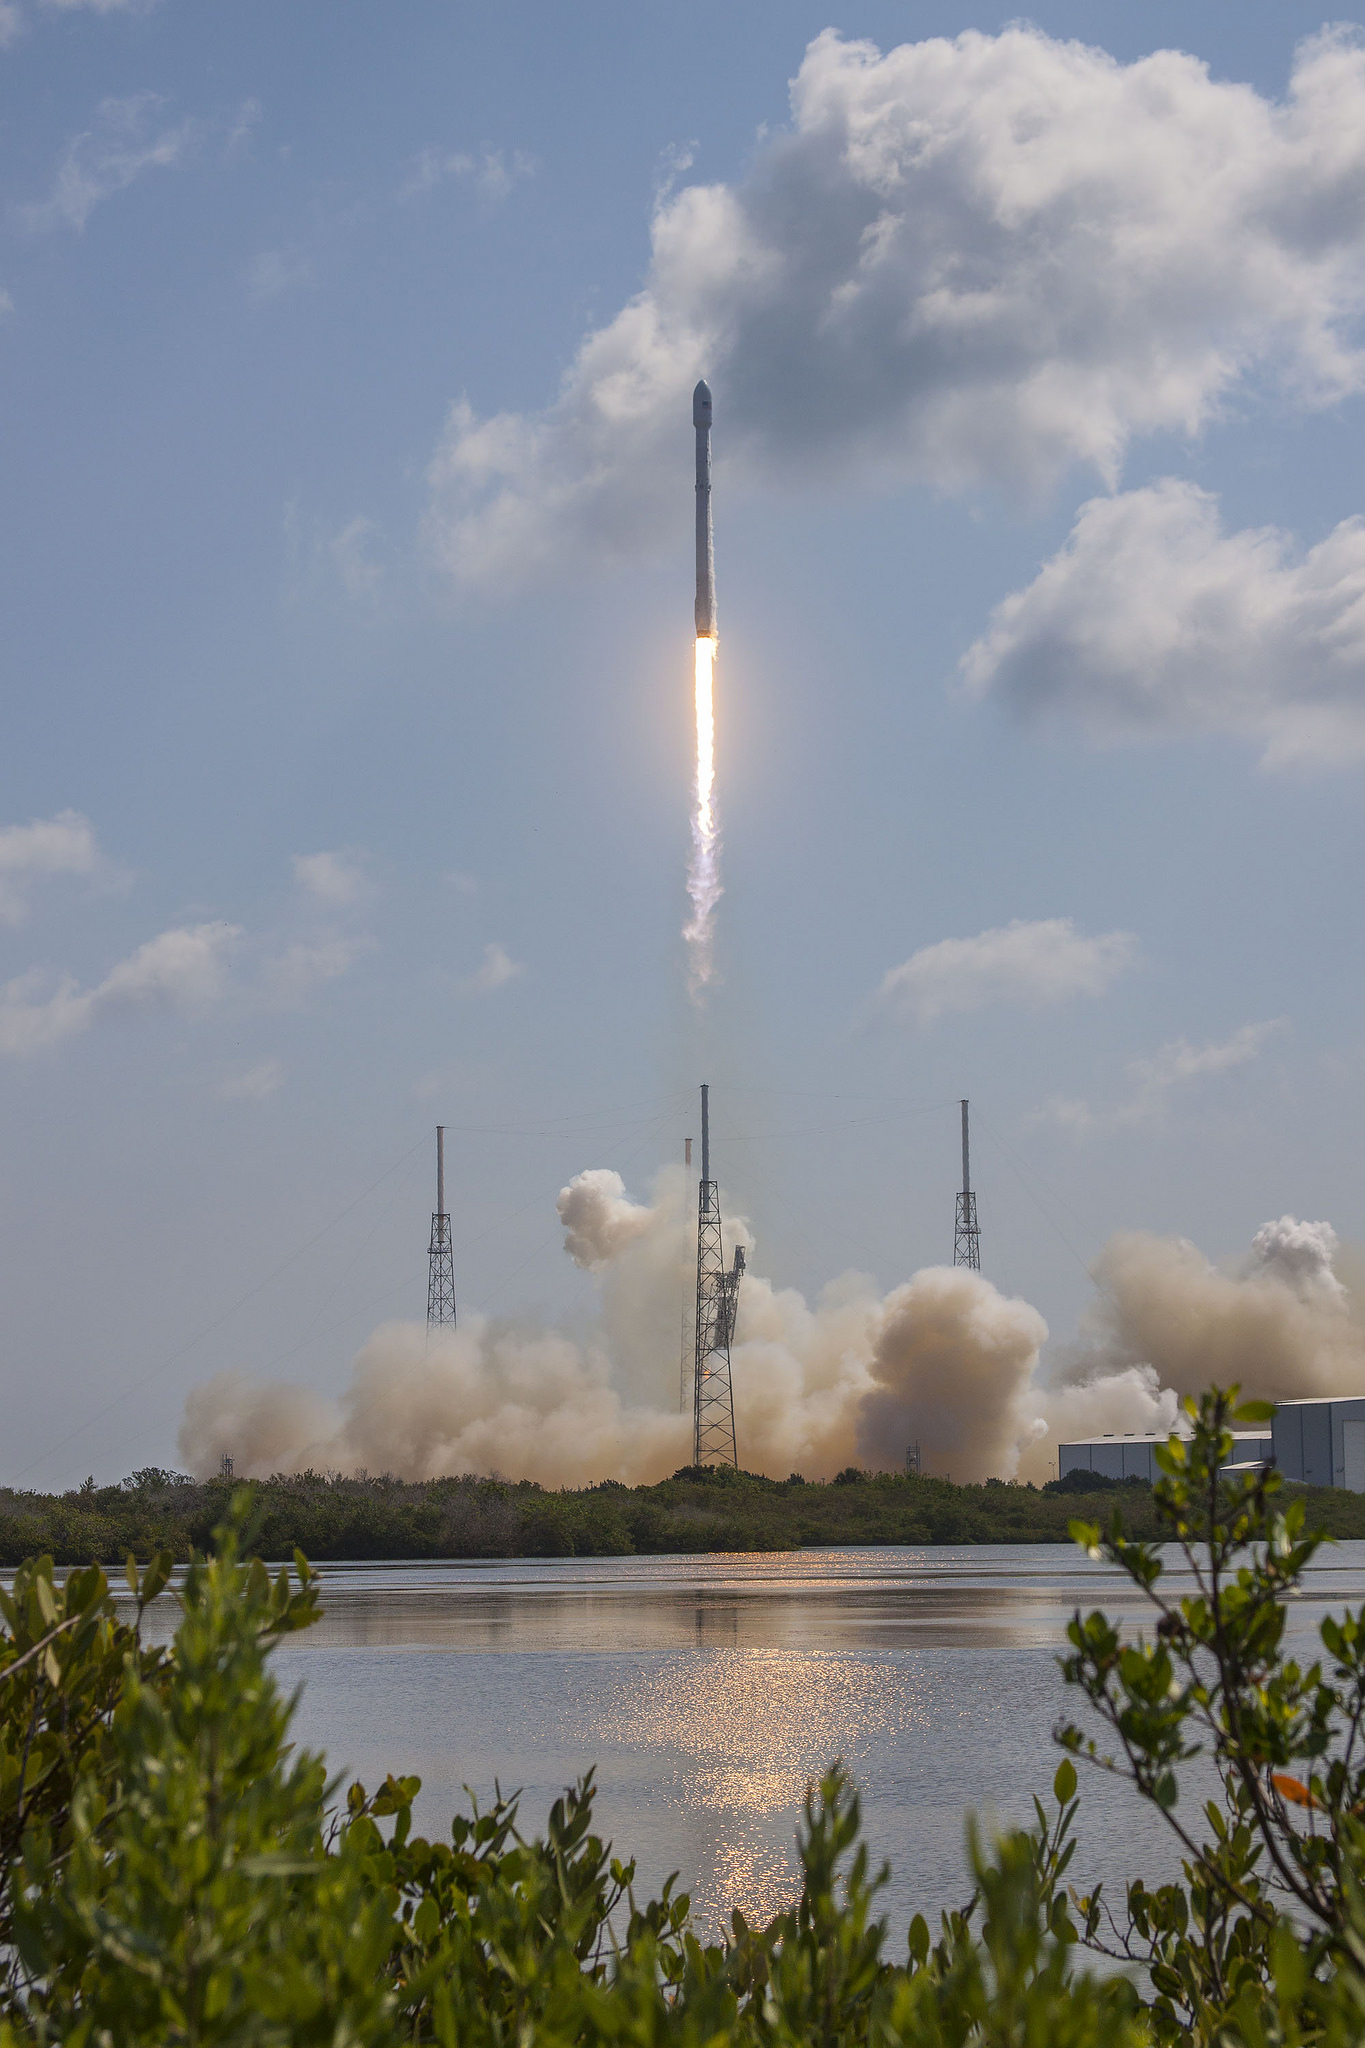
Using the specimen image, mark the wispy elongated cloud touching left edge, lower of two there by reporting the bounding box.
[0,924,241,1059]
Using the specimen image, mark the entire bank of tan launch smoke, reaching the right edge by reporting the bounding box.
[180,1167,1365,1487]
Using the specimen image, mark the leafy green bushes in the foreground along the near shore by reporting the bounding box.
[0,1393,1365,2048]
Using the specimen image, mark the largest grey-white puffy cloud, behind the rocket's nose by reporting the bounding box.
[430,27,1365,582]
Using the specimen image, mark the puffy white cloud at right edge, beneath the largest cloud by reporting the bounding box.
[962,477,1365,766]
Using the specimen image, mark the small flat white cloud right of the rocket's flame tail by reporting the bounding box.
[878,918,1138,1024]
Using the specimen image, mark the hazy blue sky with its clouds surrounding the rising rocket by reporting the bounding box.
[0,0,1365,1485]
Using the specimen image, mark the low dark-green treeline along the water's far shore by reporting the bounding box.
[0,1466,1365,1565]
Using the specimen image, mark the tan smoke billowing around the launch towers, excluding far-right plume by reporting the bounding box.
[180,1169,1048,1485]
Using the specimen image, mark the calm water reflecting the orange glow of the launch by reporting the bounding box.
[237,1542,1365,1931]
